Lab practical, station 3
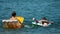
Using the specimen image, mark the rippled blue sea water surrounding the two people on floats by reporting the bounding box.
[0,0,60,34]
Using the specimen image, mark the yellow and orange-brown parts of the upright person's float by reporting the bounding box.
[4,16,24,28]
